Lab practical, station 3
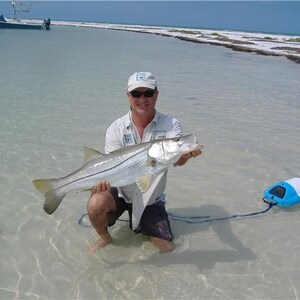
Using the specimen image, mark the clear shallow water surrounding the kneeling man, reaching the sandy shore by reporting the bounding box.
[0,26,300,299]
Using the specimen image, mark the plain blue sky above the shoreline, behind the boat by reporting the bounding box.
[0,0,300,35]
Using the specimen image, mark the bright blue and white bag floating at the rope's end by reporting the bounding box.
[263,177,300,206]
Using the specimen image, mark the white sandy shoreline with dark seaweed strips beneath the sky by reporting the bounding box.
[24,20,300,64]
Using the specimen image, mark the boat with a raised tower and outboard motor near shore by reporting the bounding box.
[0,1,51,30]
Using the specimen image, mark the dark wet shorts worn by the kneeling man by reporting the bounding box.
[108,188,174,241]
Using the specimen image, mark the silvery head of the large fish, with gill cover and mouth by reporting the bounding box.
[148,134,200,165]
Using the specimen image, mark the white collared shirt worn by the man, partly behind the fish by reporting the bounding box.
[105,111,183,230]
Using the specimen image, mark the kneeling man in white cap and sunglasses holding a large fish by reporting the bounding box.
[88,72,201,254]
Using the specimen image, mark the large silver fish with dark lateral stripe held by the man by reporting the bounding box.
[32,134,201,214]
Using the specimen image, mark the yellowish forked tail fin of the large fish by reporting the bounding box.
[32,179,66,215]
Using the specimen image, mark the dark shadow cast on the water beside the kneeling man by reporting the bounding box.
[141,205,256,270]
